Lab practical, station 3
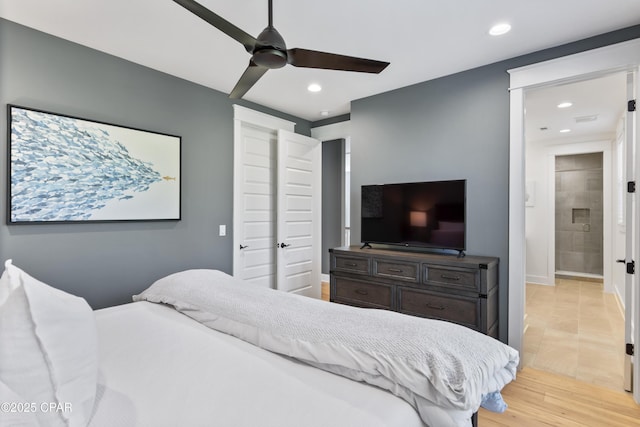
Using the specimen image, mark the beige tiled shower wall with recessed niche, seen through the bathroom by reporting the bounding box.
[555,153,603,275]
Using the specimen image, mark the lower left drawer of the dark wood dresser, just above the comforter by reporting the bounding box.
[331,277,393,309]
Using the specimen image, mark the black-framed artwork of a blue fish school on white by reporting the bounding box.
[7,105,181,224]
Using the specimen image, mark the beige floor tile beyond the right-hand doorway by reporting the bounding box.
[521,278,624,391]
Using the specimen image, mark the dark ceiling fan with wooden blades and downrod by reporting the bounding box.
[173,0,389,98]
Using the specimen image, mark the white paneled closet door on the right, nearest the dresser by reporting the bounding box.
[277,130,322,298]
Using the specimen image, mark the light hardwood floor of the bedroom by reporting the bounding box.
[322,283,640,427]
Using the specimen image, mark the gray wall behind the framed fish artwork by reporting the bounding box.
[0,19,310,308]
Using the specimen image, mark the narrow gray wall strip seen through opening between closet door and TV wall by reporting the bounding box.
[322,139,344,274]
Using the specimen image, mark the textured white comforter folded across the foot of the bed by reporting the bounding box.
[134,270,518,425]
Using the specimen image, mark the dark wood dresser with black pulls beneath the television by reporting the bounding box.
[329,246,499,339]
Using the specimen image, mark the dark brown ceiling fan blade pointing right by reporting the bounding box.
[287,48,389,74]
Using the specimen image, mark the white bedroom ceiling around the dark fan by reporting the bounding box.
[0,0,640,126]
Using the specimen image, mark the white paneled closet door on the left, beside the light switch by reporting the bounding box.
[233,123,277,288]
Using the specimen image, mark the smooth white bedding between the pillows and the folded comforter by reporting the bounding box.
[90,302,440,427]
